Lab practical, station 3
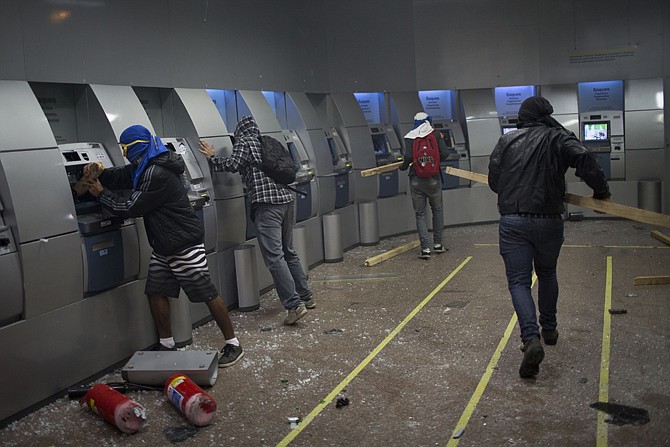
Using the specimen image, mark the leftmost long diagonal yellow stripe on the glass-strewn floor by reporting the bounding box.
[277,256,472,447]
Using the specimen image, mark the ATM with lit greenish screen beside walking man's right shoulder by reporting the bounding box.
[579,110,626,180]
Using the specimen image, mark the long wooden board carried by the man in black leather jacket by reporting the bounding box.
[445,166,670,228]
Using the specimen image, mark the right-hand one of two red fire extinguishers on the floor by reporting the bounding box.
[165,374,216,427]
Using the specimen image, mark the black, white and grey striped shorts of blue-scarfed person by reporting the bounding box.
[144,244,219,303]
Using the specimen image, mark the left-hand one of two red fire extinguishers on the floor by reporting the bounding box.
[79,383,147,433]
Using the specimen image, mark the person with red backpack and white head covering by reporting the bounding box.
[400,112,448,259]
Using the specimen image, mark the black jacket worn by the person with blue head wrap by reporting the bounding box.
[98,152,204,256]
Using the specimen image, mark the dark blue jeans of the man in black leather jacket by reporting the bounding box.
[499,214,563,343]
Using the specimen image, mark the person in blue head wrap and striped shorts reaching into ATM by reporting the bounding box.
[84,125,244,367]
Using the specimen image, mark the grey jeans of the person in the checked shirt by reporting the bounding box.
[255,202,312,309]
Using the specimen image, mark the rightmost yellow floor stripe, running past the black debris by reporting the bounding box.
[596,256,612,447]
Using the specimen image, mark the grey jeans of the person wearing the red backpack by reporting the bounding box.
[409,176,444,250]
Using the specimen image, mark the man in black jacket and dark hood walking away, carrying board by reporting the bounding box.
[488,96,610,378]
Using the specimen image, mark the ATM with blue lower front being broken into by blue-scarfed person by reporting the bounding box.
[58,143,124,295]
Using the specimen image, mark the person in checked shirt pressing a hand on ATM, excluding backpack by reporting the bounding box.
[200,116,316,325]
